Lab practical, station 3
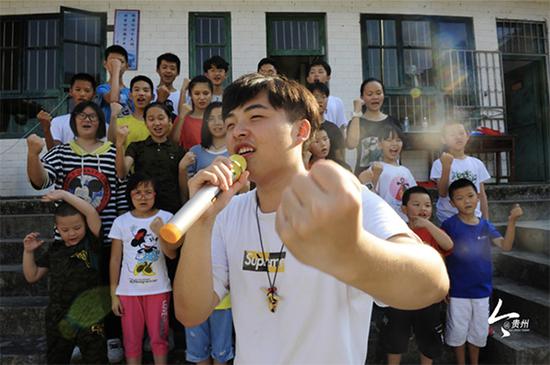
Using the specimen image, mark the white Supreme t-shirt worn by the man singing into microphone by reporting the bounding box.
[212,188,412,364]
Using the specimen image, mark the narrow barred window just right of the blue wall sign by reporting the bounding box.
[189,13,231,79]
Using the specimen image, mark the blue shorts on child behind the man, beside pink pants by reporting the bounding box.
[185,309,235,363]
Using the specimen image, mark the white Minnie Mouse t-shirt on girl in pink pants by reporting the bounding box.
[109,210,173,295]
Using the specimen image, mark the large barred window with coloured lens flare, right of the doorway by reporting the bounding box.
[361,14,478,127]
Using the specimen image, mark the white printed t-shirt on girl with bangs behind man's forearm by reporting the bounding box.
[376,162,416,222]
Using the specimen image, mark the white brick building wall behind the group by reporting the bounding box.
[0,0,550,196]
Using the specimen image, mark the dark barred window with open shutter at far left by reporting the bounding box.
[0,7,106,138]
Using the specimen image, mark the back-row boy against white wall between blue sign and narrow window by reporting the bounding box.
[155,53,181,116]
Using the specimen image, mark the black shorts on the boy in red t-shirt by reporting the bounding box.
[382,303,443,359]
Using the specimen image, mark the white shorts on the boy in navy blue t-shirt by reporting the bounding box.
[445,297,489,347]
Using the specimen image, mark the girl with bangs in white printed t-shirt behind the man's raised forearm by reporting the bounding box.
[359,124,416,222]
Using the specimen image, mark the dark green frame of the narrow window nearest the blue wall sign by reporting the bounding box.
[189,11,232,78]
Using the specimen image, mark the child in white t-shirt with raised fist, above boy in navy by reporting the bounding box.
[430,122,491,223]
